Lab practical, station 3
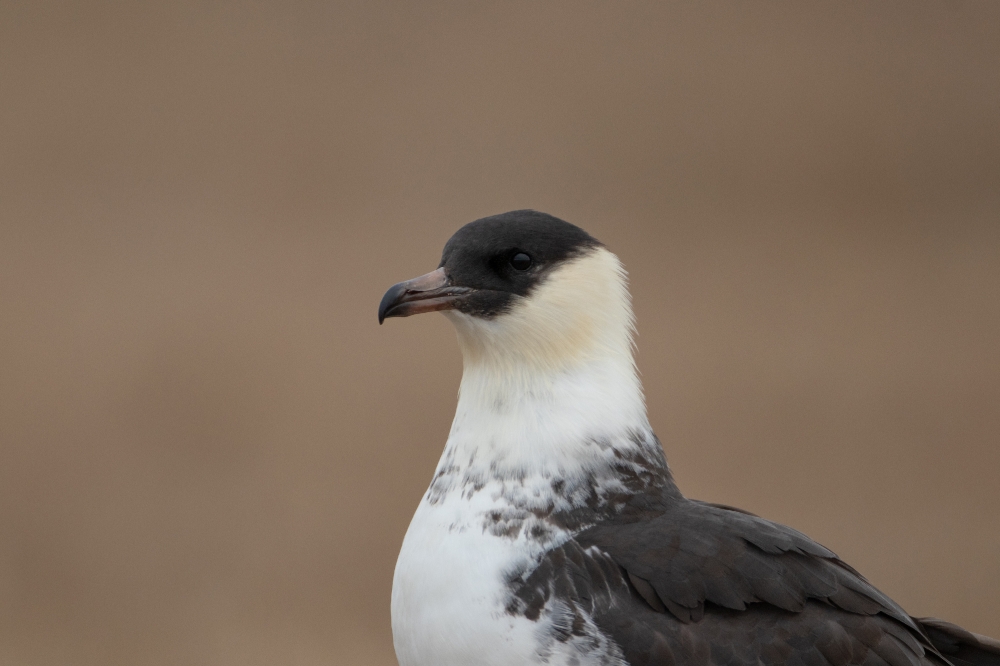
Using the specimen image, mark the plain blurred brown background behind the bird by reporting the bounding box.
[0,0,1000,666]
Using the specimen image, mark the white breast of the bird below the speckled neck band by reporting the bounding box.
[392,466,625,666]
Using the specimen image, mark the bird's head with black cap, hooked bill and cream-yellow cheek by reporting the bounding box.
[378,210,632,380]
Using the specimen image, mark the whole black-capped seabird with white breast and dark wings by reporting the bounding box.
[378,210,1000,666]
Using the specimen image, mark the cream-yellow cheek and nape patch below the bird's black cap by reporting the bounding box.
[448,248,633,378]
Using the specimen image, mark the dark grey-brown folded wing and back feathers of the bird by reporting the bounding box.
[508,446,1000,666]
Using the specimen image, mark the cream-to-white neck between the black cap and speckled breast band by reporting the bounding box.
[439,248,649,478]
